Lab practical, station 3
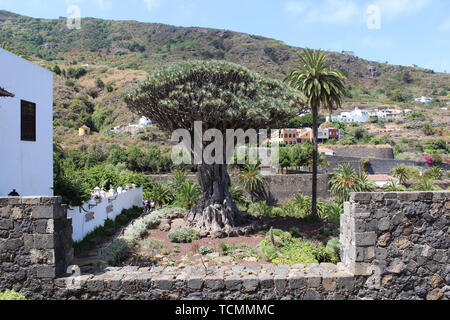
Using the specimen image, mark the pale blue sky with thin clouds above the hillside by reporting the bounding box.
[0,0,450,72]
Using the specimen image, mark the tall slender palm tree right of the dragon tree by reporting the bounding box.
[285,49,346,216]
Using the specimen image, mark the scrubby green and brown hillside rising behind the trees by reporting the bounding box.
[0,10,450,154]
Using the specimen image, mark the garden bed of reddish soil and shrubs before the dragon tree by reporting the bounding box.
[78,208,339,271]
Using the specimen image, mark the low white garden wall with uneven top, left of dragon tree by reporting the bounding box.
[67,185,143,241]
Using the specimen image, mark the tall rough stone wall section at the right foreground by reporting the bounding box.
[341,192,450,299]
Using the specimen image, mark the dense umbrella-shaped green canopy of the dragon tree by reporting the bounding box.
[125,61,304,132]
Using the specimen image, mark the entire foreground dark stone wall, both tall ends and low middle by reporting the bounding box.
[0,192,450,300]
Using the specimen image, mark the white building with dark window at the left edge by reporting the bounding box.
[0,48,53,196]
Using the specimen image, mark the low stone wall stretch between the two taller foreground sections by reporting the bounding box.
[54,263,355,300]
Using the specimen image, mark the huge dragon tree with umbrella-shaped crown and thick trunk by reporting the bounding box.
[125,61,304,234]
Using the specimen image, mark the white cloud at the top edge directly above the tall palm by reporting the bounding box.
[284,0,364,24]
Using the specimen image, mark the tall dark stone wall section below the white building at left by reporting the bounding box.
[0,197,73,299]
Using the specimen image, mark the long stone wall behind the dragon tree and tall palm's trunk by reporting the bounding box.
[148,174,331,203]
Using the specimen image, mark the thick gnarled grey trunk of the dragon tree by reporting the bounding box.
[187,164,247,235]
